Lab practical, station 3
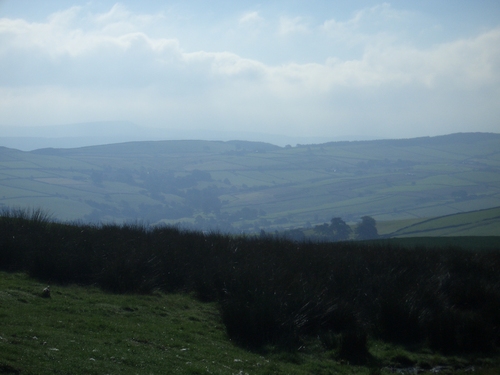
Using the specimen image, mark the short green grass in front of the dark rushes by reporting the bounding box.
[0,272,500,375]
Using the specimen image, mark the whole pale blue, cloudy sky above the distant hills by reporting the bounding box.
[0,0,500,141]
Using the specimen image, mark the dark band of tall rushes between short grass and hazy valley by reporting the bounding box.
[0,210,500,356]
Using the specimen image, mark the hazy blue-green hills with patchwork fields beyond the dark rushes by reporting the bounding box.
[0,133,500,234]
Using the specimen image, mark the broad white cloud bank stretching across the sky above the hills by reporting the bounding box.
[0,4,500,140]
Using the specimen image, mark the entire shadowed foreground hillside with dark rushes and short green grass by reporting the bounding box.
[0,211,500,375]
